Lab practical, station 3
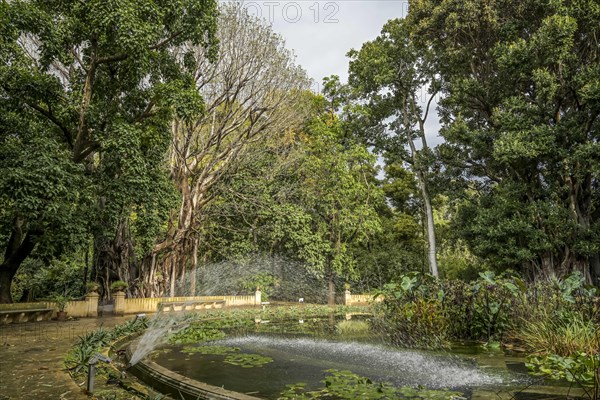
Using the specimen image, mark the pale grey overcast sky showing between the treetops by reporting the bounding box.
[227,0,441,146]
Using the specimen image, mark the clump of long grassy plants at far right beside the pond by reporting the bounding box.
[511,273,600,386]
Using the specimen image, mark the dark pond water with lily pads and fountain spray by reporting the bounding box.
[143,316,580,399]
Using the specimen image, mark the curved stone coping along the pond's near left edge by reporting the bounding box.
[126,337,260,400]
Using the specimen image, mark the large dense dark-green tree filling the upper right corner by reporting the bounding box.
[408,0,600,283]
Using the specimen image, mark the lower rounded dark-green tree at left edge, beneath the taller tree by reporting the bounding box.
[0,108,93,303]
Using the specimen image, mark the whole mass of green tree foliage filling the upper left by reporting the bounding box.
[0,0,217,301]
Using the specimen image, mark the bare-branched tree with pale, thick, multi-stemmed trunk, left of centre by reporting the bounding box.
[138,4,308,296]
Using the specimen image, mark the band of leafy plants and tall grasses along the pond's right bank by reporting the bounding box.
[375,271,600,348]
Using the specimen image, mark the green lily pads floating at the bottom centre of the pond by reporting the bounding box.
[279,369,461,400]
